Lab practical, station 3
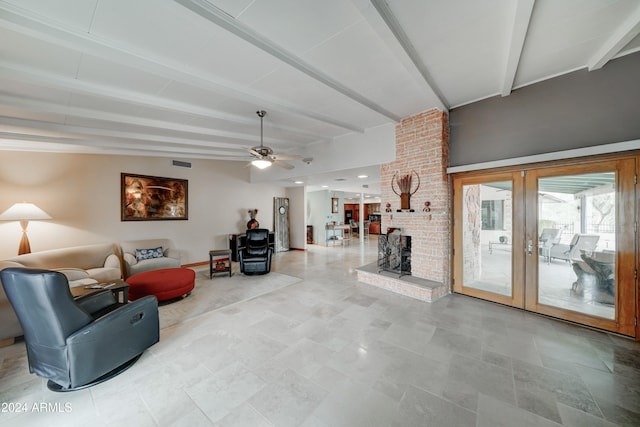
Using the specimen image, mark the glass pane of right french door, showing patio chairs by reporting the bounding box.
[538,172,616,319]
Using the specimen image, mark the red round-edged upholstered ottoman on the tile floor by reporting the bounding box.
[125,268,196,301]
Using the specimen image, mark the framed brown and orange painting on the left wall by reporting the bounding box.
[120,173,189,221]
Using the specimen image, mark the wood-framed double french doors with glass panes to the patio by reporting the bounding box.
[453,157,637,336]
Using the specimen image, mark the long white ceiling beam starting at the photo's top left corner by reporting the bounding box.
[0,0,364,133]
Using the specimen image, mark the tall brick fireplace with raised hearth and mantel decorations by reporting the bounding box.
[358,109,451,301]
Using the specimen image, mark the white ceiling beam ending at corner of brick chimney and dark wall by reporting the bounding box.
[367,0,450,111]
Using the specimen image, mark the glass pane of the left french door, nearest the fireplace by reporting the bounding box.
[462,181,513,296]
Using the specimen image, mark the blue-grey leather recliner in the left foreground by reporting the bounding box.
[0,268,160,391]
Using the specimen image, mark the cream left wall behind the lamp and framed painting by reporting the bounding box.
[0,151,290,264]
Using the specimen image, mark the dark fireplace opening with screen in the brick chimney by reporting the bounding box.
[378,228,411,276]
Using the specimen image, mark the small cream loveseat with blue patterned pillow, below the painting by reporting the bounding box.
[120,239,182,277]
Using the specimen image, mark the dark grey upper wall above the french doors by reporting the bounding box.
[449,52,640,166]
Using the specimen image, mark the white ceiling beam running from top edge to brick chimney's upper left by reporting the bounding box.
[174,0,402,122]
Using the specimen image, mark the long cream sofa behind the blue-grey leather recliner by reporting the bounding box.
[0,243,122,341]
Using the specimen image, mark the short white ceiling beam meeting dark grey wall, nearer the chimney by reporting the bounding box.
[500,0,535,96]
